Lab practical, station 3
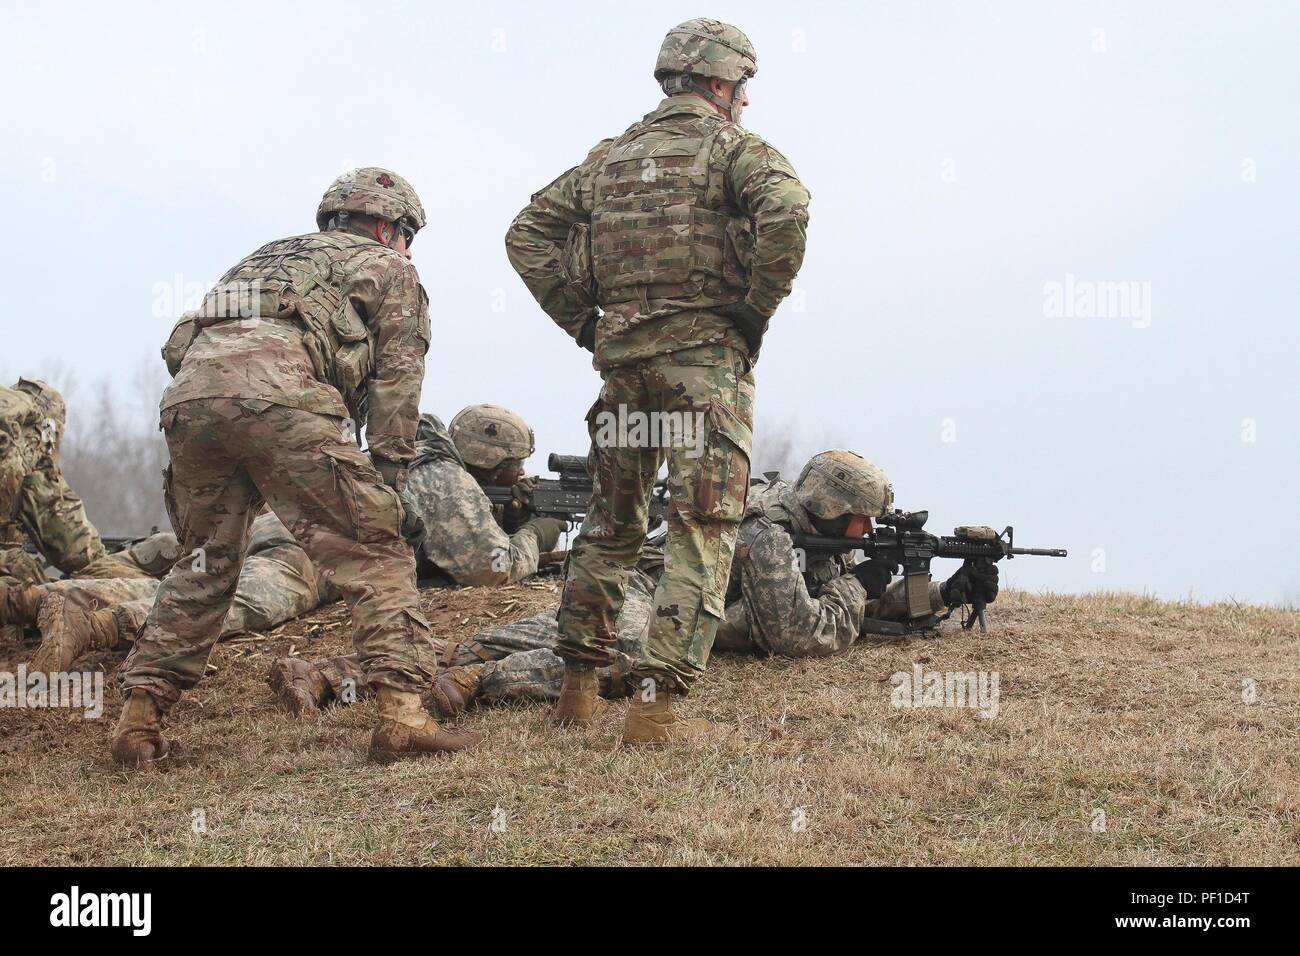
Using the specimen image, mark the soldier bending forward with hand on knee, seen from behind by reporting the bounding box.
[112,168,476,765]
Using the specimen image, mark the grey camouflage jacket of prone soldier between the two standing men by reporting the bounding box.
[407,415,541,587]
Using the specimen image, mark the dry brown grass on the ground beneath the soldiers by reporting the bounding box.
[0,584,1300,865]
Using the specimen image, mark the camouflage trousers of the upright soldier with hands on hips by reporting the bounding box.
[556,346,754,693]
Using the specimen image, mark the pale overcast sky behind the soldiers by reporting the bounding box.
[0,0,1300,602]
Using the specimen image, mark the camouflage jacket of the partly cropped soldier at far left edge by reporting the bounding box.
[0,378,104,587]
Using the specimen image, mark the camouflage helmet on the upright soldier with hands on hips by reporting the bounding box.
[654,17,758,122]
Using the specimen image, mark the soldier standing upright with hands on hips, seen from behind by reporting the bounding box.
[506,20,809,744]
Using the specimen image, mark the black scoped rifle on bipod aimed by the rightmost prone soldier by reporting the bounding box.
[793,510,1066,635]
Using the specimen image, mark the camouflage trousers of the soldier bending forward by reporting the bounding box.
[120,398,437,708]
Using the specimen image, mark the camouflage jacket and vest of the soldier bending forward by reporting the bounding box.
[161,232,430,463]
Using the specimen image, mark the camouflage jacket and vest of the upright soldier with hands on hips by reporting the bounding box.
[506,95,809,368]
